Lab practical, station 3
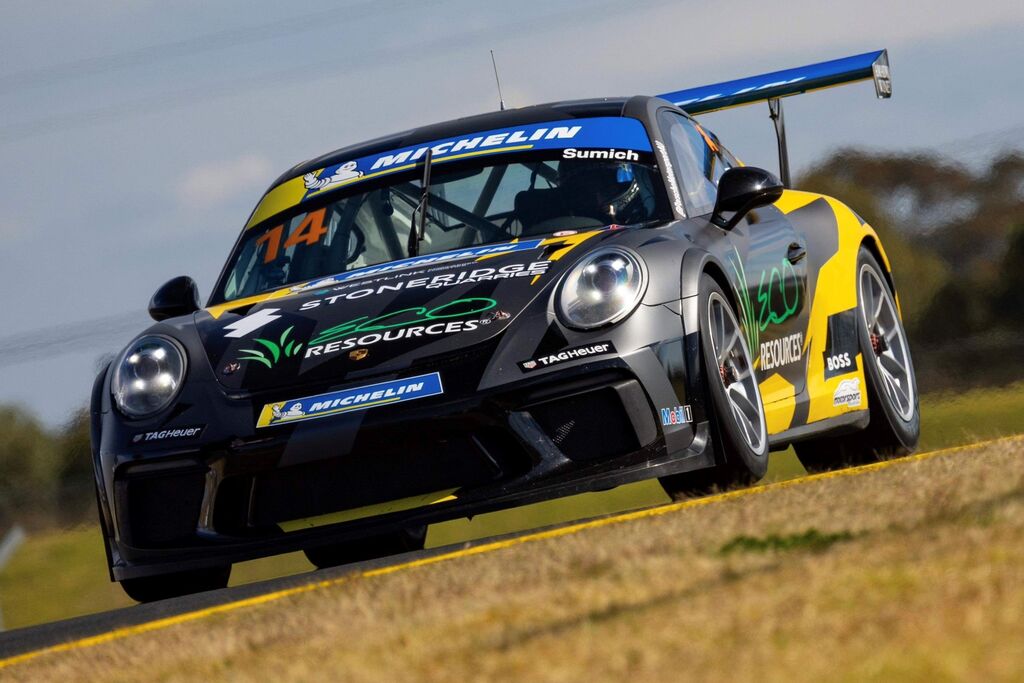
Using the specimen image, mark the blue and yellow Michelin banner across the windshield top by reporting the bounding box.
[246,117,651,232]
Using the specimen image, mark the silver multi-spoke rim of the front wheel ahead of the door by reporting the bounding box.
[708,292,767,455]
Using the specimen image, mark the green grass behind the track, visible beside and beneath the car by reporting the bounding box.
[0,383,1024,629]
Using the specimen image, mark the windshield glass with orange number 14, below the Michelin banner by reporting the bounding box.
[214,122,672,301]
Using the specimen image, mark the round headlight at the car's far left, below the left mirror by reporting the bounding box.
[111,337,185,418]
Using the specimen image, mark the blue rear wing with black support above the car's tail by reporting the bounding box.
[658,50,893,186]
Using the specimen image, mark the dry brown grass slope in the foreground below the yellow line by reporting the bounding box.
[8,439,1024,682]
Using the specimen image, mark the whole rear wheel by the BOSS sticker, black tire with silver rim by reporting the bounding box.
[794,247,921,473]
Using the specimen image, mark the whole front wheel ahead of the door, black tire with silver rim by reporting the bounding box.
[660,273,768,500]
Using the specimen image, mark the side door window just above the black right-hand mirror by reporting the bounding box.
[657,110,725,216]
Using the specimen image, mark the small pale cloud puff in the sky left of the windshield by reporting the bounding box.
[177,154,273,208]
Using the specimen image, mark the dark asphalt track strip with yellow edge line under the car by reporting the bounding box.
[0,439,1008,670]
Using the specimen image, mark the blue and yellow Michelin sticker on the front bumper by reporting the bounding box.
[256,373,444,427]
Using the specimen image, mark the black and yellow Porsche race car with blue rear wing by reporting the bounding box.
[92,51,920,601]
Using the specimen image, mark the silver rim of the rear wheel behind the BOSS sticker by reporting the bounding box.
[860,264,915,422]
